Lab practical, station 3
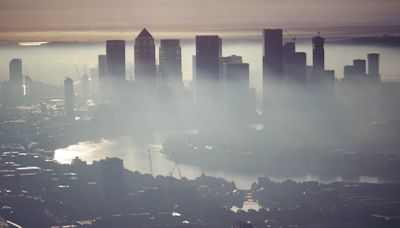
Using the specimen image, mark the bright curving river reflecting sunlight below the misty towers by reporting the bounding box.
[54,137,380,189]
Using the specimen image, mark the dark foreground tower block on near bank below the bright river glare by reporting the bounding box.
[100,157,124,200]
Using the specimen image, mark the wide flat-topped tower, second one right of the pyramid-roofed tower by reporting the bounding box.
[195,36,222,103]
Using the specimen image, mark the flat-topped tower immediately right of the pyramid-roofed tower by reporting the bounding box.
[160,40,183,87]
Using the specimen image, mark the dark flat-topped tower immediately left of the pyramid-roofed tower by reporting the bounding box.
[105,40,125,83]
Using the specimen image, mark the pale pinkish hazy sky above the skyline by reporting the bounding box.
[0,0,400,39]
